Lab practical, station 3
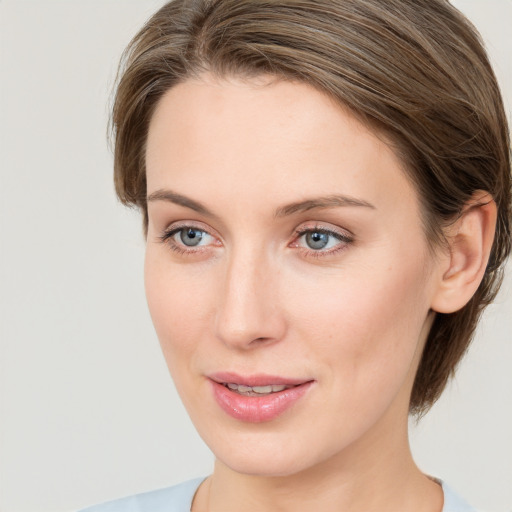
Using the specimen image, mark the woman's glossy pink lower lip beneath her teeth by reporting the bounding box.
[210,380,313,423]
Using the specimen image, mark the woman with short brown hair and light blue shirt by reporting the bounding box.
[82,0,511,512]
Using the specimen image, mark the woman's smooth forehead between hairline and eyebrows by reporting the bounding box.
[146,75,416,220]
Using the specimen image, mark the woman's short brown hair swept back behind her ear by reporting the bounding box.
[112,0,511,413]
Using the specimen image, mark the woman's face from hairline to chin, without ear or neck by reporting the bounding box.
[145,75,440,475]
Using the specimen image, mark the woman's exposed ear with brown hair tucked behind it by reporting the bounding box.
[431,190,496,313]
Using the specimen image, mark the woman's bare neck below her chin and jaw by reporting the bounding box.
[193,404,443,512]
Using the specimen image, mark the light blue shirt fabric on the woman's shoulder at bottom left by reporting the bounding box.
[80,478,204,512]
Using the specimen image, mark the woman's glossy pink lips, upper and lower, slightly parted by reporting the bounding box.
[208,373,314,423]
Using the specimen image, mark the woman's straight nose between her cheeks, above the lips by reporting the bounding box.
[215,247,286,350]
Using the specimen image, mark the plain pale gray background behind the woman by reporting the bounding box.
[0,0,512,512]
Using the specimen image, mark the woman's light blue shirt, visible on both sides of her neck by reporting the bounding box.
[81,478,476,512]
